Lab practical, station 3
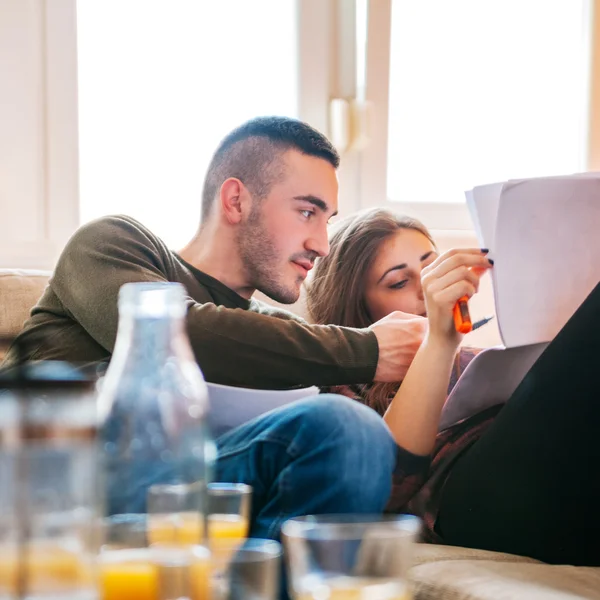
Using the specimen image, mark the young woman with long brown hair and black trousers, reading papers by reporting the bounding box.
[307,209,600,565]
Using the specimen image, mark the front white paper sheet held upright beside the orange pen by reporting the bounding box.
[493,175,600,348]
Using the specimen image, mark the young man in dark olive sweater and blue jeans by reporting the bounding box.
[3,117,426,535]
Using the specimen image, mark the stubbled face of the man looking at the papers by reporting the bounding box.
[238,150,338,304]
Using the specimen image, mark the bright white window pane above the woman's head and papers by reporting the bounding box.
[360,0,591,228]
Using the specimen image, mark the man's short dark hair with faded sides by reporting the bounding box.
[202,117,340,220]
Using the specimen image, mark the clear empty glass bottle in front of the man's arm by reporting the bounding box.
[98,283,216,547]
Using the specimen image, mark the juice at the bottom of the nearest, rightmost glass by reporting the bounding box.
[296,576,412,600]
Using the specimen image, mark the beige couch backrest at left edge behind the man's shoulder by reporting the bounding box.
[0,269,51,359]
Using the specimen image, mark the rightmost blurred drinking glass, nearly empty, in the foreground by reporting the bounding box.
[282,514,421,600]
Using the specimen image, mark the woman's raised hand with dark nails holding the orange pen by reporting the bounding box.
[421,248,493,347]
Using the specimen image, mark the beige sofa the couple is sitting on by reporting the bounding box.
[0,269,600,600]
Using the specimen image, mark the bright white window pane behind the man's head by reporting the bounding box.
[77,0,298,248]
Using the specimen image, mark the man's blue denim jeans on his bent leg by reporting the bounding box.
[215,394,397,539]
